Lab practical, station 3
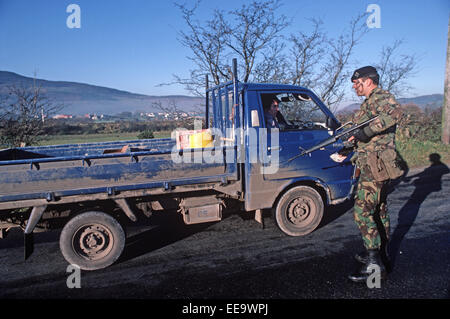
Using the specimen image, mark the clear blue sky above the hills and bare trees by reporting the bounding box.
[0,0,450,104]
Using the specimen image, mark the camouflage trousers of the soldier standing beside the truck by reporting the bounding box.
[353,167,390,249]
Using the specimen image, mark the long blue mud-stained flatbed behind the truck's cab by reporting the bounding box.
[0,139,234,209]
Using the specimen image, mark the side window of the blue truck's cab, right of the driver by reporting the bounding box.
[277,93,327,130]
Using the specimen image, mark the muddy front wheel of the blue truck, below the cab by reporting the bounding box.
[275,186,324,236]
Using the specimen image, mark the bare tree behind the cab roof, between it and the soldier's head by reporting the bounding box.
[254,14,368,110]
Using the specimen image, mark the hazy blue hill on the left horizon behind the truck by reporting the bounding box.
[0,71,204,115]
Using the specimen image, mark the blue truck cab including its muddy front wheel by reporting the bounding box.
[206,81,356,236]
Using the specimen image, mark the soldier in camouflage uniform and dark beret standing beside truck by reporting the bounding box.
[349,66,403,282]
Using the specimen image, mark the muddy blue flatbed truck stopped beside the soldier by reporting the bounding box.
[0,61,356,270]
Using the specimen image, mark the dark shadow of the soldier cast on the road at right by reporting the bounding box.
[389,153,450,267]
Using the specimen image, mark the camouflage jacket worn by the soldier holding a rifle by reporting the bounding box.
[352,87,403,167]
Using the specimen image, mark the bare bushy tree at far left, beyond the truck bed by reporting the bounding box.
[0,85,63,147]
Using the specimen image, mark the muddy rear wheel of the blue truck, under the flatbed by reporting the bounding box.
[59,211,125,270]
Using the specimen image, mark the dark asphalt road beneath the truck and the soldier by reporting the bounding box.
[0,164,450,300]
